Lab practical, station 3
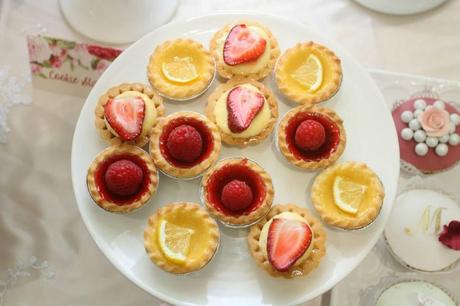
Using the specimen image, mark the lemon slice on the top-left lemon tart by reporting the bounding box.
[162,56,198,83]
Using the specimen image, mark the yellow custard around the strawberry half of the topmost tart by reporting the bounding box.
[218,26,271,74]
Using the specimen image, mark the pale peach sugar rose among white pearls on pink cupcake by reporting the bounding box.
[419,106,451,137]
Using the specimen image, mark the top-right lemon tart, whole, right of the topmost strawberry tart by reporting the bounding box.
[275,41,342,104]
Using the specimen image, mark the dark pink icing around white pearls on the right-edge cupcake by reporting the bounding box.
[392,97,460,173]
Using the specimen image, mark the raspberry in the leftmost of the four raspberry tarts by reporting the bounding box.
[105,159,144,196]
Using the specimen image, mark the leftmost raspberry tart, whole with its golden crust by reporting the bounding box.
[86,144,158,213]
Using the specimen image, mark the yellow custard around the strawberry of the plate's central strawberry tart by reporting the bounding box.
[214,84,271,138]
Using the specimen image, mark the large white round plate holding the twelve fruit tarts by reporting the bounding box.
[72,13,399,306]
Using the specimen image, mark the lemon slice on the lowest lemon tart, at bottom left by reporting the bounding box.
[158,220,194,264]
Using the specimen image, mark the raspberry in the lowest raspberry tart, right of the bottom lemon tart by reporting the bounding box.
[221,180,253,211]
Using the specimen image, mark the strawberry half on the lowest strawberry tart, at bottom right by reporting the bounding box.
[267,219,312,272]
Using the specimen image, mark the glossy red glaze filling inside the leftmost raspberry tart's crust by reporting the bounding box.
[94,154,150,205]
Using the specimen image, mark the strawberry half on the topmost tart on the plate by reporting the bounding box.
[224,24,267,66]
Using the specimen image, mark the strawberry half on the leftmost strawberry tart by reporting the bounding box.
[104,97,145,141]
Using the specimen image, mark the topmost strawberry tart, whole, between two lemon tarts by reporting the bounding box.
[210,21,280,80]
